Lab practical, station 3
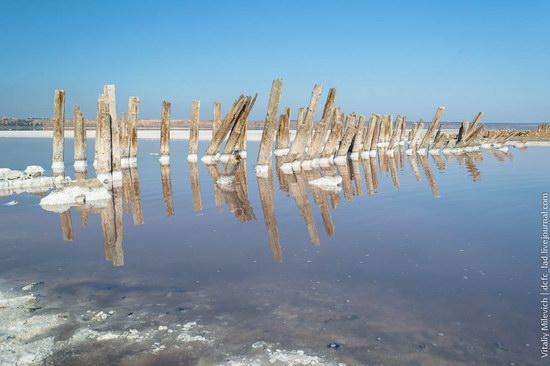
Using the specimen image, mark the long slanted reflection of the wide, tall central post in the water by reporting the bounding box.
[256,169,283,262]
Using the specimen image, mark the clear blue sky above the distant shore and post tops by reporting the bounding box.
[0,0,550,123]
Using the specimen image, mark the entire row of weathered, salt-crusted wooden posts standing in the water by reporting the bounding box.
[52,80,514,180]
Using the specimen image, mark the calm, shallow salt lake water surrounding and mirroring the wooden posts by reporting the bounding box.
[0,139,550,365]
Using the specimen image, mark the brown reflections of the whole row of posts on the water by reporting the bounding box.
[46,146,512,266]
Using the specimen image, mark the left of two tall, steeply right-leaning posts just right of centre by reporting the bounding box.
[282,85,323,170]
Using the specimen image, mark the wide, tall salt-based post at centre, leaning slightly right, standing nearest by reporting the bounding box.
[256,79,283,177]
